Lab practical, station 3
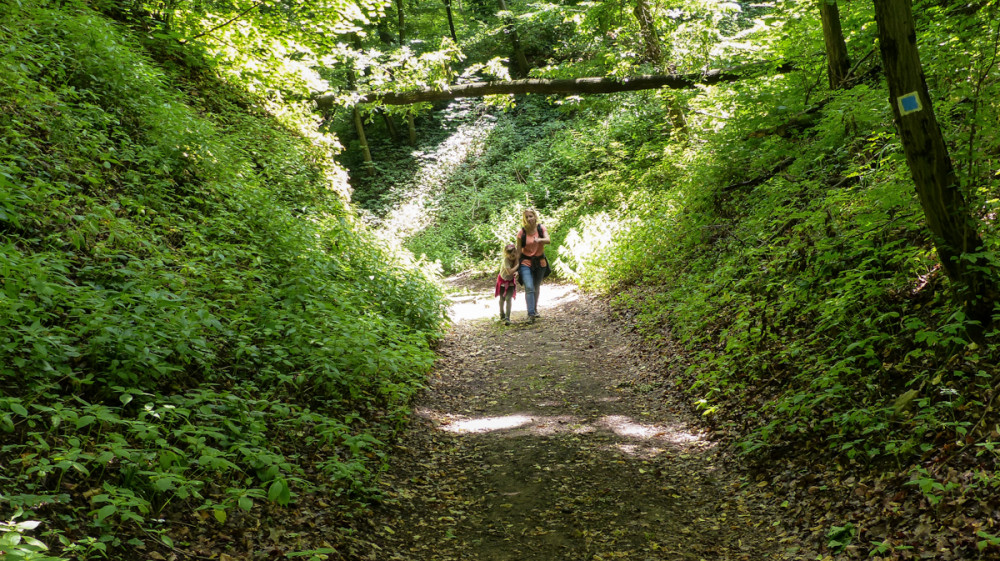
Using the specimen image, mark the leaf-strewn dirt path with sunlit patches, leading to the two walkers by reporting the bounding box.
[369,280,780,561]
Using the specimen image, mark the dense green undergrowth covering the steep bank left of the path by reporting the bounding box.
[0,0,443,559]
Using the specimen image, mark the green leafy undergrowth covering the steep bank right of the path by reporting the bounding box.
[592,83,1000,559]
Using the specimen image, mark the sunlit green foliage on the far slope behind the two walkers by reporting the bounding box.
[353,92,669,280]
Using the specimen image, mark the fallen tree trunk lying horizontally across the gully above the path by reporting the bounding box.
[316,62,795,109]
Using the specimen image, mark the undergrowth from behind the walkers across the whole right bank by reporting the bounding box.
[342,3,1000,558]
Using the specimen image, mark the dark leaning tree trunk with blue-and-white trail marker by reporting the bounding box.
[875,0,997,326]
